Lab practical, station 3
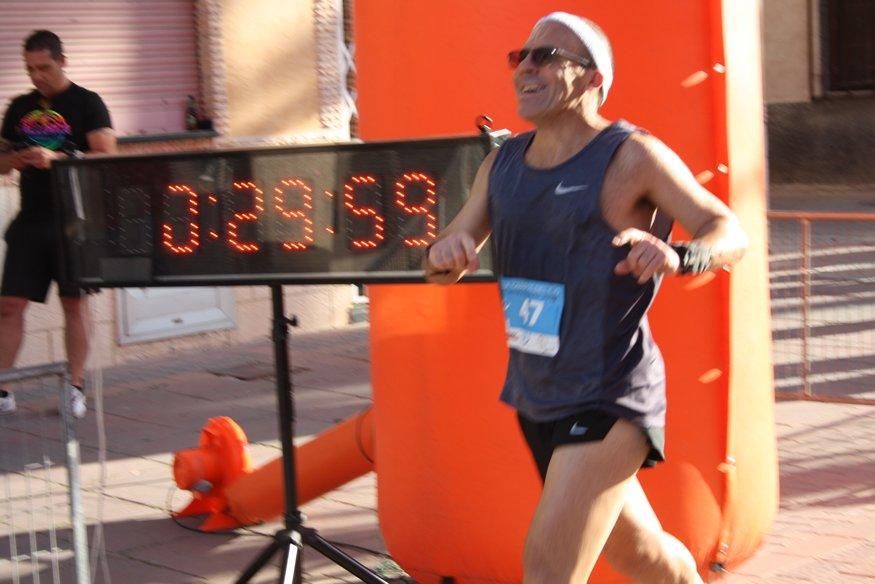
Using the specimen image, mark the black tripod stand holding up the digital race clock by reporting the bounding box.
[237,284,388,584]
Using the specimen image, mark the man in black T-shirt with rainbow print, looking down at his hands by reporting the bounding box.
[0,30,116,418]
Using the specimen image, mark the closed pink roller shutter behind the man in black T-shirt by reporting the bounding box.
[0,0,200,135]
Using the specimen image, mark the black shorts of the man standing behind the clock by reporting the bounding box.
[0,219,90,302]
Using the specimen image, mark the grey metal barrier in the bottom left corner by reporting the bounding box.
[0,363,91,584]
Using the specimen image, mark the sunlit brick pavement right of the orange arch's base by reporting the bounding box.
[726,401,875,584]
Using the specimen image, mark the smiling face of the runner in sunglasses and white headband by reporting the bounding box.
[513,22,594,122]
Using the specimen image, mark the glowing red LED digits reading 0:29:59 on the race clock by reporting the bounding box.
[155,170,438,255]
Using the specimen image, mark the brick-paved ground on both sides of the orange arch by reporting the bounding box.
[0,326,875,584]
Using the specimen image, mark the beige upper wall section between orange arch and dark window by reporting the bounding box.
[763,0,813,103]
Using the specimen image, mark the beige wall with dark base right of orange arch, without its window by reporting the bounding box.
[762,0,875,186]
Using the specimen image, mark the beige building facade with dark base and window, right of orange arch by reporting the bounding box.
[761,0,875,184]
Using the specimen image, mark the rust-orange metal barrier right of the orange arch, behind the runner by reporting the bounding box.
[768,211,875,405]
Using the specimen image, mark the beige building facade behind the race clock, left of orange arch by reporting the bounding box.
[0,0,360,369]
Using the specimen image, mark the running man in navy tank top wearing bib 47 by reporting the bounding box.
[425,12,747,584]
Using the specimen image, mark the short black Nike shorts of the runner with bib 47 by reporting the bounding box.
[517,410,665,481]
